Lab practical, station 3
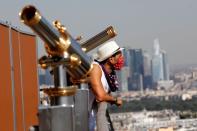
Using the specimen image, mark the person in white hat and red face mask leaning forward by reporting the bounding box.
[89,41,124,131]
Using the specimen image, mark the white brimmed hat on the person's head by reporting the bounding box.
[96,41,123,62]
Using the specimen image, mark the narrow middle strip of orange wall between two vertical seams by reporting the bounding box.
[11,28,25,131]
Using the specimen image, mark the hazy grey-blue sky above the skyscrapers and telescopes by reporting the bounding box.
[0,0,197,65]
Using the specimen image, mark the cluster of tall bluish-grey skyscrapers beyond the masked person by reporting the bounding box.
[118,39,173,91]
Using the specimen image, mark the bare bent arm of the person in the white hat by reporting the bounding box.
[89,64,122,105]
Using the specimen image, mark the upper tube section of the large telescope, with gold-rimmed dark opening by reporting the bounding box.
[20,5,60,50]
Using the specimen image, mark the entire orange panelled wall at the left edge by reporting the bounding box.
[0,22,39,131]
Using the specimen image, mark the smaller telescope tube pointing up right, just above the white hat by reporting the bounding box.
[81,26,117,52]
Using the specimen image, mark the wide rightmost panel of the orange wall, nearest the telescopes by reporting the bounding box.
[20,33,39,130]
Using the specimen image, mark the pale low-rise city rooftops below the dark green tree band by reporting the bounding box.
[110,110,197,131]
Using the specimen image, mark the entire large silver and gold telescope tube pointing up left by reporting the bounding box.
[20,5,92,79]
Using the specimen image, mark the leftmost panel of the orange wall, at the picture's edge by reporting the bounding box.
[0,24,14,131]
